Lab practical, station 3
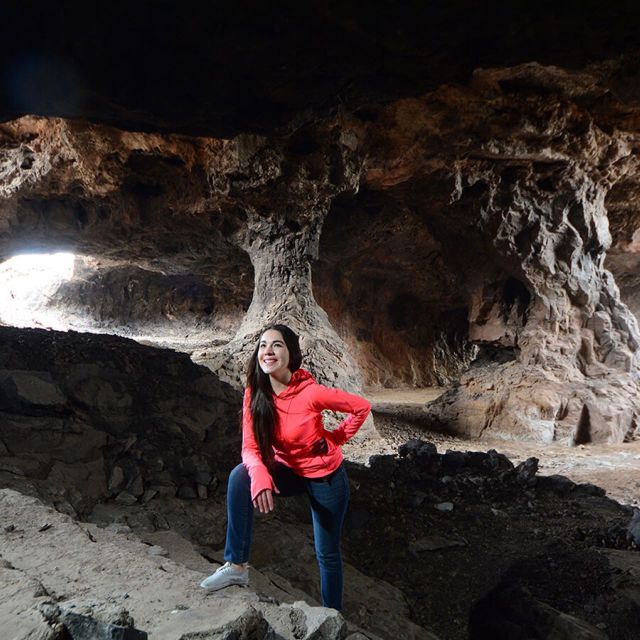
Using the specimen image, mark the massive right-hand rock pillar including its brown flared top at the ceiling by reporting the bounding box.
[356,65,638,442]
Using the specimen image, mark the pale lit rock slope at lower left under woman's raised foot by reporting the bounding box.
[0,489,370,640]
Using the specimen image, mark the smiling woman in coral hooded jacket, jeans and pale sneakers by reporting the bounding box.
[200,324,371,610]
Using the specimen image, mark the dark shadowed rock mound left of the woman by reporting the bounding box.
[0,328,240,513]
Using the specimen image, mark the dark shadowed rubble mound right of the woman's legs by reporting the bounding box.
[346,441,637,640]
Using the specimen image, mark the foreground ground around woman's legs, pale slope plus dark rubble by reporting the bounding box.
[5,422,640,640]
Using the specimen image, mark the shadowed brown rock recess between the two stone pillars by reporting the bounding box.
[313,191,475,387]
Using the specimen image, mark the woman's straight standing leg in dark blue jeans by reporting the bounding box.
[308,465,349,610]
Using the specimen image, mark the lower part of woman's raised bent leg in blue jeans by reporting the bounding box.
[224,464,253,564]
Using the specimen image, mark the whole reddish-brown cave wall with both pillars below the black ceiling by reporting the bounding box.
[0,31,640,443]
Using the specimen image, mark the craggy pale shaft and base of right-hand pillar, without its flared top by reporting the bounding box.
[429,164,640,445]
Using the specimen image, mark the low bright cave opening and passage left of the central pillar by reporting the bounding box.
[0,246,251,353]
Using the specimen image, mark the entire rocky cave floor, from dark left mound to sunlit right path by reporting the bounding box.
[0,328,640,640]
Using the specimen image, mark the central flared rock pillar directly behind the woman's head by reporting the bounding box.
[198,124,370,391]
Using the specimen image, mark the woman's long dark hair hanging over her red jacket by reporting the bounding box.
[247,324,302,466]
